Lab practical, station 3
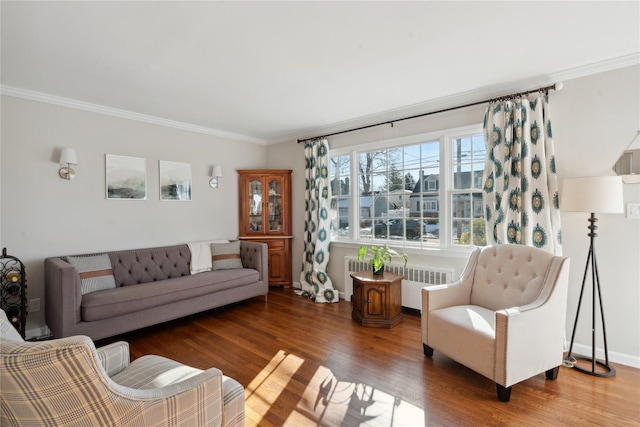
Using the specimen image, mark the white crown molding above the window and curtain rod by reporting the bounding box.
[274,52,640,145]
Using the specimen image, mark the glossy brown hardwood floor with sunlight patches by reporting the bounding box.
[110,289,640,427]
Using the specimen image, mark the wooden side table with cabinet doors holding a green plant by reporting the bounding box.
[351,271,403,329]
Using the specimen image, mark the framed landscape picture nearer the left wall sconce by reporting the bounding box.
[105,154,147,200]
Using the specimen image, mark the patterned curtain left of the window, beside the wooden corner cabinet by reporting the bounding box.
[297,139,338,303]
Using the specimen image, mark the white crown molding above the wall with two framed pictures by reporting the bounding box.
[0,85,267,145]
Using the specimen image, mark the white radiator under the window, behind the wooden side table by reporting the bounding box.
[344,257,454,310]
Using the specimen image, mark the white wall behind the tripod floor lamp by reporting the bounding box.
[551,66,640,367]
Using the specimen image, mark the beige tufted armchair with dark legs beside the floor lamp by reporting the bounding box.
[421,244,569,402]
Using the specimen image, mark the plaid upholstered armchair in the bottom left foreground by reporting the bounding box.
[0,310,244,426]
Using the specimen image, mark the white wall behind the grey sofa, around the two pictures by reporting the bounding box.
[0,96,267,334]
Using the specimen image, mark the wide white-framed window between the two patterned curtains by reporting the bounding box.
[330,126,486,247]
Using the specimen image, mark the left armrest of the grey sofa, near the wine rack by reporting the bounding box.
[44,257,82,338]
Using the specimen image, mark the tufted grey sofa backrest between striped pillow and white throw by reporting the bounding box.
[108,245,191,286]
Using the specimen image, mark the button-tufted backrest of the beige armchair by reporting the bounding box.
[471,244,554,310]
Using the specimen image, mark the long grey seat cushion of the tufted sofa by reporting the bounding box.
[81,268,259,321]
